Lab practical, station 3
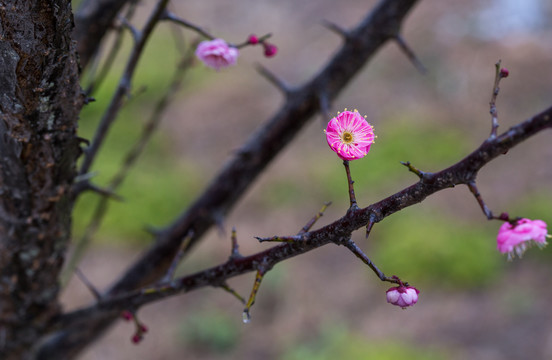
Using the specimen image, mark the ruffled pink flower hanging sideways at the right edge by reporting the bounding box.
[496,219,547,260]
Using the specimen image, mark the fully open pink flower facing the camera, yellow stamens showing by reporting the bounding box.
[326,109,374,160]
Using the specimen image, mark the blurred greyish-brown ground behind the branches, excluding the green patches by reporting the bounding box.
[64,0,552,360]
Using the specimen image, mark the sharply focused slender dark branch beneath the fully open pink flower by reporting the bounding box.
[53,107,552,327]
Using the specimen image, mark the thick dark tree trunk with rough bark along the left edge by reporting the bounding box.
[0,0,83,359]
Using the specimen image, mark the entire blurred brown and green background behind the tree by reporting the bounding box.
[63,0,552,360]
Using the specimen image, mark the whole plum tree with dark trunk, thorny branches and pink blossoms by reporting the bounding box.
[0,0,552,360]
